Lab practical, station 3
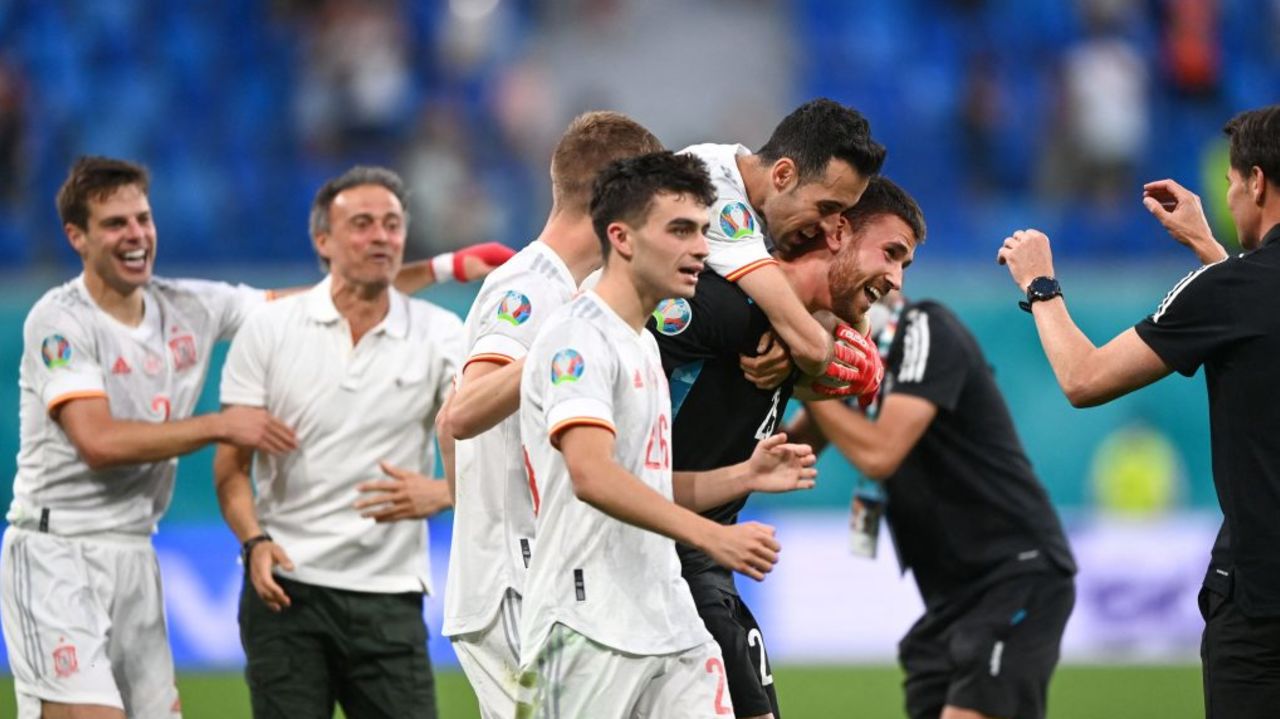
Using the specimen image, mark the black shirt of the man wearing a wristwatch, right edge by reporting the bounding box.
[1134,225,1280,617]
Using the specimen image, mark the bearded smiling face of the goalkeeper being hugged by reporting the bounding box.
[827,214,915,325]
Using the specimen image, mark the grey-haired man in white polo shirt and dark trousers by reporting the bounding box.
[215,168,462,719]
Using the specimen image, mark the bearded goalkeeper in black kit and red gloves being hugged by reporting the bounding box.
[649,177,924,719]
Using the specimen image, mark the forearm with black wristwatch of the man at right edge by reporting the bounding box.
[997,230,1172,407]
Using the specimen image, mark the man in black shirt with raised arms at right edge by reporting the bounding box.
[997,105,1280,719]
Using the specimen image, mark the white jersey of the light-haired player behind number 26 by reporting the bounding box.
[443,241,576,636]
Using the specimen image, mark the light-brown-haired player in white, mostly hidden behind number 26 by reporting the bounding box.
[443,113,662,719]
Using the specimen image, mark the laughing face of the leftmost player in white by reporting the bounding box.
[63,184,156,296]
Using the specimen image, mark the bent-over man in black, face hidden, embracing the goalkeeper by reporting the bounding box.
[791,293,1075,719]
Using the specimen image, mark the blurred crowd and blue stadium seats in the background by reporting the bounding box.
[0,0,1280,269]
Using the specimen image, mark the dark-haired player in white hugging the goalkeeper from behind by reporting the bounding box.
[684,99,884,388]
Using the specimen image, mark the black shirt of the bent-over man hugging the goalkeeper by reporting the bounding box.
[881,301,1075,606]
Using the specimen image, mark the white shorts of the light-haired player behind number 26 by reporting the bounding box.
[452,589,520,719]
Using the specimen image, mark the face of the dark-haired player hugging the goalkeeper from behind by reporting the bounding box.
[760,157,868,248]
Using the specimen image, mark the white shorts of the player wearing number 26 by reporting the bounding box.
[516,624,733,719]
